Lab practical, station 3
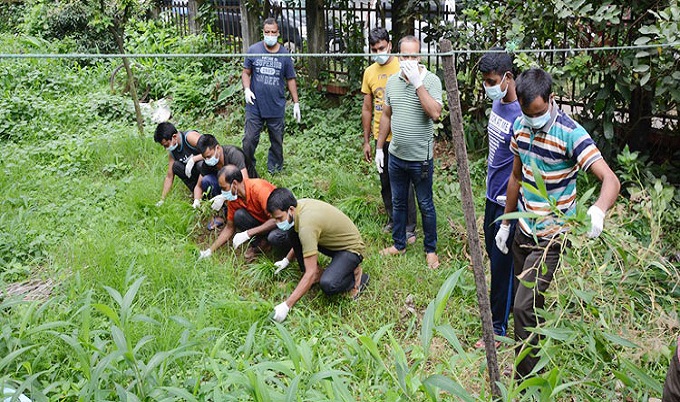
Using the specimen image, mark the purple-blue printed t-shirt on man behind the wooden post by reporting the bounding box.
[486,100,522,205]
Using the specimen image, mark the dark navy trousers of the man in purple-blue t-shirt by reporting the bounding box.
[484,198,517,336]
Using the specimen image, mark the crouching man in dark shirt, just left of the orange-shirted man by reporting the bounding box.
[194,134,258,226]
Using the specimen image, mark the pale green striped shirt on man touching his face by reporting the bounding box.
[385,64,442,162]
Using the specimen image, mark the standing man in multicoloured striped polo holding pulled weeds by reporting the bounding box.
[496,68,620,379]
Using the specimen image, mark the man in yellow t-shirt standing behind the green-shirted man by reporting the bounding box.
[361,27,416,244]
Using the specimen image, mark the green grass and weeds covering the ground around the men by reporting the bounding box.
[0,35,680,401]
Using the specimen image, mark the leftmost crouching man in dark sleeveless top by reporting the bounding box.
[153,122,203,207]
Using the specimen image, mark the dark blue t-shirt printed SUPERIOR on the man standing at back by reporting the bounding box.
[243,42,295,119]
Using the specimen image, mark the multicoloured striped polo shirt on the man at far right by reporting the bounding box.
[510,102,602,238]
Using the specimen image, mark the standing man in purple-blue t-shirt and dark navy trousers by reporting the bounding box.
[475,47,522,348]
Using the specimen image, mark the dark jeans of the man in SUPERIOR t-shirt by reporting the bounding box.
[241,112,284,173]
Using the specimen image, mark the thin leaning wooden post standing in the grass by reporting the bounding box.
[439,39,501,398]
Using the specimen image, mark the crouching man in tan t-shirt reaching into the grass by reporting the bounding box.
[267,188,369,322]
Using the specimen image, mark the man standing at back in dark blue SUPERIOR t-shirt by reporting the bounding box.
[241,18,301,173]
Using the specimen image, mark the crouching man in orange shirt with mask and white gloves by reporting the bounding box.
[199,165,287,262]
